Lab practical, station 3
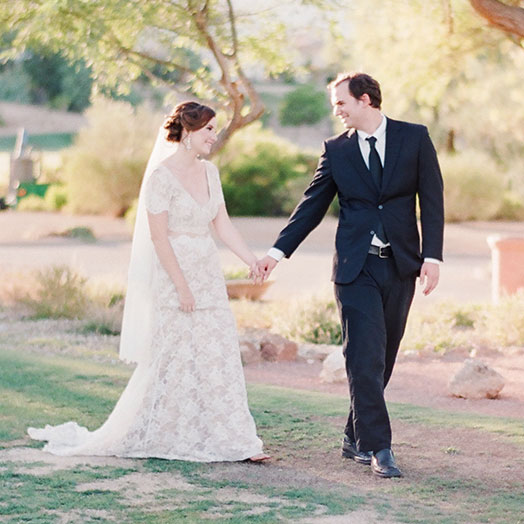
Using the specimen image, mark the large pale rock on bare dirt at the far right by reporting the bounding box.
[448,358,505,399]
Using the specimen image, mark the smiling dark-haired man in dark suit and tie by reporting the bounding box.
[259,73,444,478]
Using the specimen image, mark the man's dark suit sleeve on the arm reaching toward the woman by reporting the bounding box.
[273,142,337,258]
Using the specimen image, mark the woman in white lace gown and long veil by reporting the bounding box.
[28,102,269,462]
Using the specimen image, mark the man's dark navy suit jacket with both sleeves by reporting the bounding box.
[274,118,444,284]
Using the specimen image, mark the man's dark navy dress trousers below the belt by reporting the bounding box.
[335,254,416,451]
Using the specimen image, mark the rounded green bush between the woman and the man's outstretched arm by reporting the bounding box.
[216,122,317,216]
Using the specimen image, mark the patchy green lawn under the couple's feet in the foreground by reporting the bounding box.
[0,344,524,524]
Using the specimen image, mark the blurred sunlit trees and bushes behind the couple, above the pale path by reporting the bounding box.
[0,0,524,221]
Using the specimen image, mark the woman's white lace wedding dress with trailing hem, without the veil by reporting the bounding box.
[28,161,262,462]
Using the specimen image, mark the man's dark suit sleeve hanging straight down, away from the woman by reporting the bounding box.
[418,128,444,260]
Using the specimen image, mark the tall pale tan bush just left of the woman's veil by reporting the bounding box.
[64,98,161,216]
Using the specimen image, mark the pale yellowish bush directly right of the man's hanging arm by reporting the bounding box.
[440,151,521,222]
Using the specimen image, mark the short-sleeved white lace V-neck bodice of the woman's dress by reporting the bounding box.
[145,160,224,235]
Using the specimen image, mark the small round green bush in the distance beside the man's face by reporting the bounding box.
[280,85,330,126]
